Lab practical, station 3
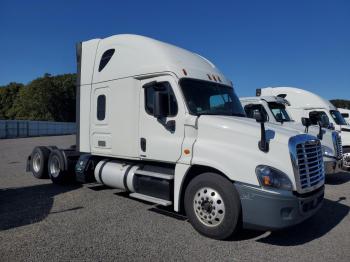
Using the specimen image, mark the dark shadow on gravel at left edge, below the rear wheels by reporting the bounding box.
[0,184,82,231]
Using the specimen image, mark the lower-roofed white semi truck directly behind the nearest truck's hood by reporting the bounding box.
[240,96,343,174]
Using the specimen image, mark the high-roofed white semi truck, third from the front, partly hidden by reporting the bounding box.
[256,87,350,170]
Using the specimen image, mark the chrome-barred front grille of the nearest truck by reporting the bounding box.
[296,140,324,191]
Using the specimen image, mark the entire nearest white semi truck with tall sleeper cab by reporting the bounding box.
[27,35,325,239]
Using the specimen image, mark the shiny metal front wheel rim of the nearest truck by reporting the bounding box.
[193,187,225,227]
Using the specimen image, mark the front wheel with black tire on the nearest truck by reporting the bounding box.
[184,173,241,239]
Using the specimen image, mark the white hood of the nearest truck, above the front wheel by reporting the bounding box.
[192,115,322,189]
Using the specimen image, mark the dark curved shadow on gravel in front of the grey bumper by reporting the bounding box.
[256,197,350,246]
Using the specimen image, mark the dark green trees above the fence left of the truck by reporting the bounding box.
[0,74,76,122]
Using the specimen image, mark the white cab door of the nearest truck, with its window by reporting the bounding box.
[139,76,185,163]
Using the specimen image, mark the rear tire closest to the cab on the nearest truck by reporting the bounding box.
[48,149,71,185]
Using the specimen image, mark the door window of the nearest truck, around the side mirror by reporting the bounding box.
[144,82,178,116]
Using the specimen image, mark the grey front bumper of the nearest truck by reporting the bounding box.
[234,183,324,230]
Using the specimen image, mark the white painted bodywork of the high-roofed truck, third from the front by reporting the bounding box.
[261,87,350,147]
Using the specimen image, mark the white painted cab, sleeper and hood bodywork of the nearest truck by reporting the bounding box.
[78,35,323,211]
